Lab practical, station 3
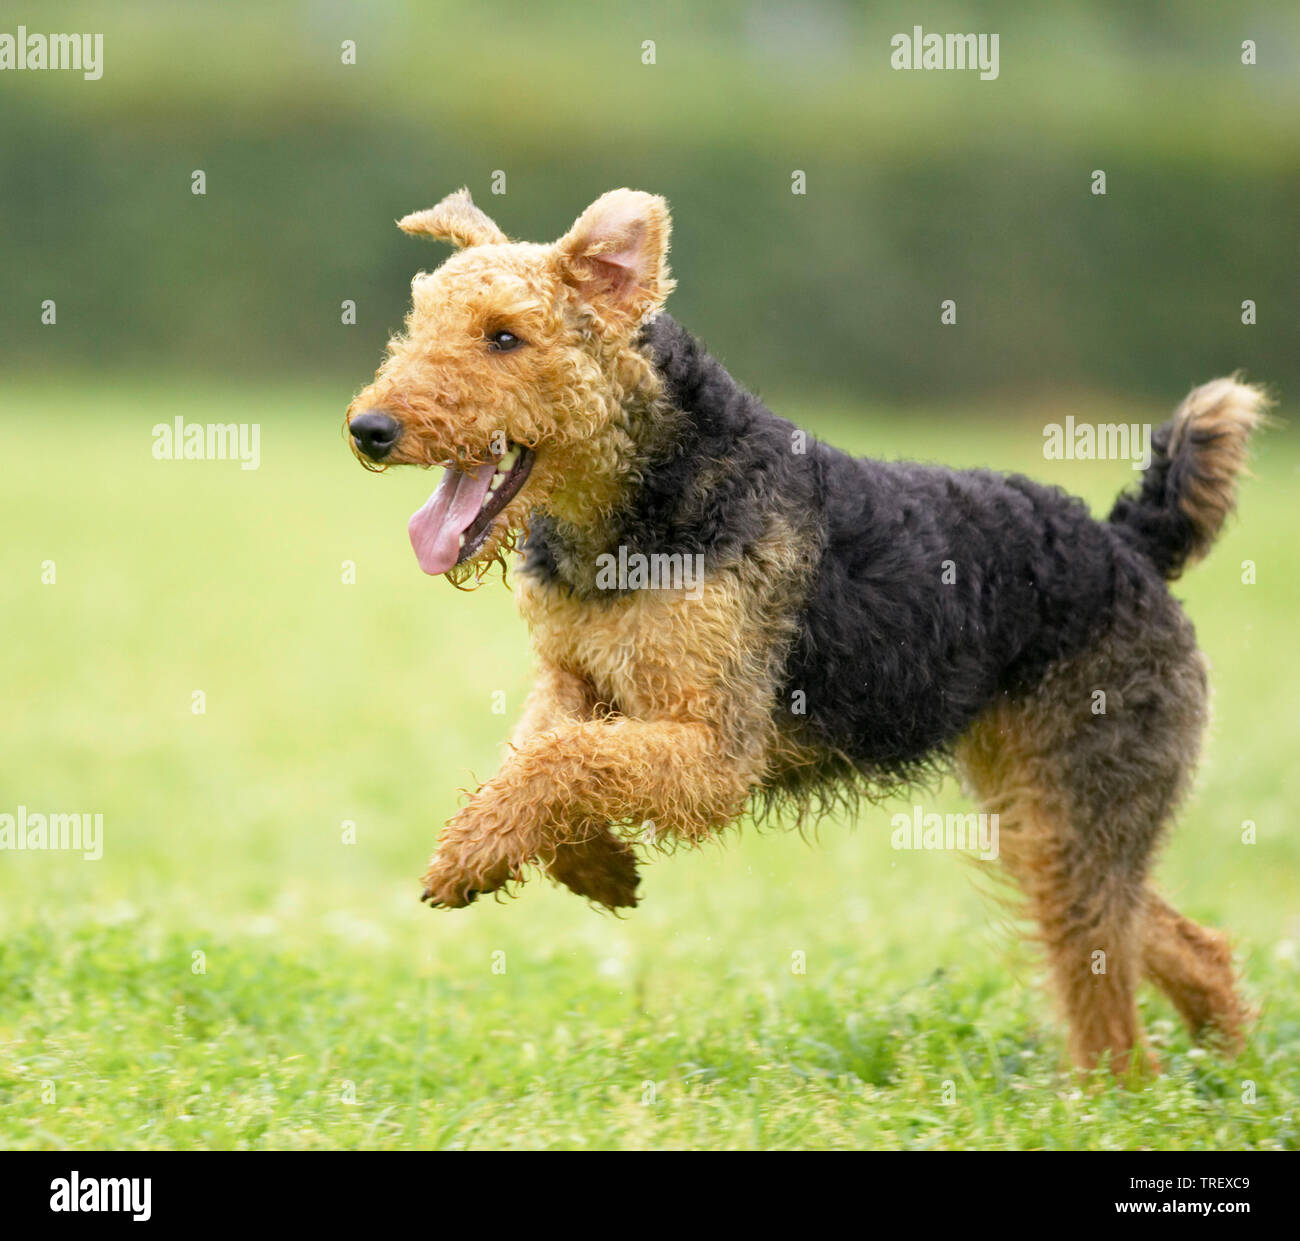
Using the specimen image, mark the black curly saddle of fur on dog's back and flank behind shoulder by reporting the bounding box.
[785,444,1128,782]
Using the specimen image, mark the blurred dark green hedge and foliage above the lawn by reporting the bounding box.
[0,3,1300,400]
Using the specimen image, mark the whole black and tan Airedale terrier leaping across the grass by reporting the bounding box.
[348,190,1265,1072]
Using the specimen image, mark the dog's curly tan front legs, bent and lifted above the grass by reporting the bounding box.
[424,716,753,908]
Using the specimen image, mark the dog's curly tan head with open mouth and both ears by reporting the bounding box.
[347,190,672,583]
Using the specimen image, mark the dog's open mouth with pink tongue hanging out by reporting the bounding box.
[407,444,533,574]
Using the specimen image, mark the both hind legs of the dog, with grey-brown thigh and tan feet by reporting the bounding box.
[958,594,1216,1072]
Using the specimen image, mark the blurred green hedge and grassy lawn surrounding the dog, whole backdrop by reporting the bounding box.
[0,3,1300,1150]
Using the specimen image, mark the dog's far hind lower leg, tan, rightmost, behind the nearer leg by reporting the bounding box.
[1143,890,1248,1053]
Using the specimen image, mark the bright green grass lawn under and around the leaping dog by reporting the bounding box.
[0,385,1300,1149]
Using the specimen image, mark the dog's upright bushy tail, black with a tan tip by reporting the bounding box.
[1110,376,1269,580]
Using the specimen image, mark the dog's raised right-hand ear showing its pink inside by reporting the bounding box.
[555,190,672,324]
